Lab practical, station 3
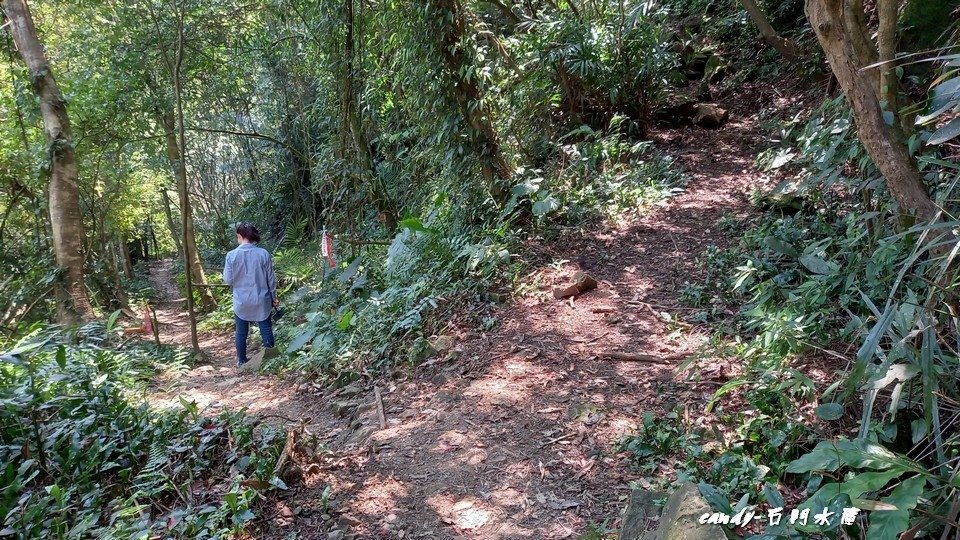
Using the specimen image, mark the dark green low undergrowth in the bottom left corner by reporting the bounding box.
[0,317,286,539]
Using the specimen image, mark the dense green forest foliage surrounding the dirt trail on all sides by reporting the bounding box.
[0,0,960,538]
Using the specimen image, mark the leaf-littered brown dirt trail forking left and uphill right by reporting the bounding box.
[142,90,772,539]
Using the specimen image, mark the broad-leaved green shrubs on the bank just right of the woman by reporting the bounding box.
[274,209,510,377]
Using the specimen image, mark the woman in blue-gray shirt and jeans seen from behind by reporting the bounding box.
[223,222,279,367]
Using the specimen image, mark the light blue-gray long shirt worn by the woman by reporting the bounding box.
[223,244,277,322]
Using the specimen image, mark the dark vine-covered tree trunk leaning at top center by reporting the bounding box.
[430,0,512,205]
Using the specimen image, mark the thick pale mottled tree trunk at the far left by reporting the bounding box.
[3,0,94,324]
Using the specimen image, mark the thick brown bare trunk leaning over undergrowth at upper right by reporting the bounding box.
[805,0,937,221]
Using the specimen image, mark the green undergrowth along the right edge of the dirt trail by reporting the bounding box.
[622,64,960,539]
